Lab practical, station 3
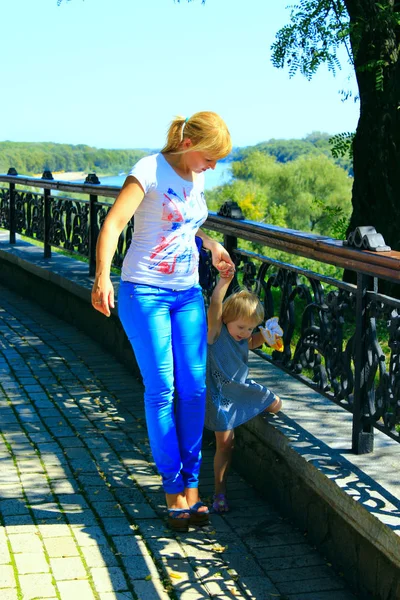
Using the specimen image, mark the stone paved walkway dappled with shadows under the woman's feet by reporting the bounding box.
[0,287,355,600]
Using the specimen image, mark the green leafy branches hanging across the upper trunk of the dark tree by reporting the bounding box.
[271,0,400,103]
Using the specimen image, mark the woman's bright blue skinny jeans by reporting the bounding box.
[118,281,207,494]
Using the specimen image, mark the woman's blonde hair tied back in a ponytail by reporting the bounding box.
[161,111,232,160]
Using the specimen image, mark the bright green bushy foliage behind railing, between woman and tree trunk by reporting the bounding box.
[206,145,352,239]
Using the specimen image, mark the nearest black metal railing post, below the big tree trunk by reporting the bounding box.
[352,273,378,454]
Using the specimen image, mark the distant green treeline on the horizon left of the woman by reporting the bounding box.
[0,142,149,175]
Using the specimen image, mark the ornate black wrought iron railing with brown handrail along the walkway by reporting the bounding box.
[0,174,400,453]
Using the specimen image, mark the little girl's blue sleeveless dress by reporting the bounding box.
[205,324,276,431]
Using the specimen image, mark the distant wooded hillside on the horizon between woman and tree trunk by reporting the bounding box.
[232,131,353,175]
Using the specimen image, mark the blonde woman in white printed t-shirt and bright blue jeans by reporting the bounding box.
[92,112,234,531]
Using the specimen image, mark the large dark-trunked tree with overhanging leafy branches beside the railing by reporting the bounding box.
[272,0,400,255]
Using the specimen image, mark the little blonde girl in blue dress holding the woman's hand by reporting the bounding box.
[205,273,283,513]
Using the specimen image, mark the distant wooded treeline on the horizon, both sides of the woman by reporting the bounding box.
[0,132,353,175]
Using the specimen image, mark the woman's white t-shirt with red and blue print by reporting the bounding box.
[121,153,208,290]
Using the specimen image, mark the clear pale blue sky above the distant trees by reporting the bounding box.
[0,0,359,148]
